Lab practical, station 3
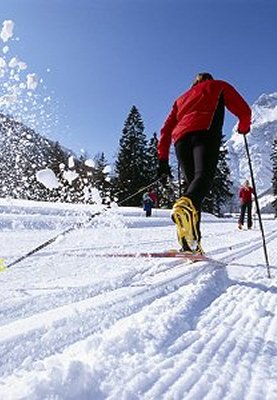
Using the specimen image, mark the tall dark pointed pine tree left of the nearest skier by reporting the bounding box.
[115,106,149,206]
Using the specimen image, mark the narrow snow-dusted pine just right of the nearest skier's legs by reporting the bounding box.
[203,139,233,216]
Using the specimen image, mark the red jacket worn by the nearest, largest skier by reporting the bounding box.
[158,80,251,160]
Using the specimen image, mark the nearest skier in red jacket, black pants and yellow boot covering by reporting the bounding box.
[158,72,251,254]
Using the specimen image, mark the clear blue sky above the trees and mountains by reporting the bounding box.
[0,0,277,162]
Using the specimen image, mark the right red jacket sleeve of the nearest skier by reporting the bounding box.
[223,83,251,134]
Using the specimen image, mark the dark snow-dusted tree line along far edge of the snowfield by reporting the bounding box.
[0,106,277,216]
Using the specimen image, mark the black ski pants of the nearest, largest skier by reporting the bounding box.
[175,130,222,237]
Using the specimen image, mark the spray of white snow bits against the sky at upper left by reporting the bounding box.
[0,20,58,140]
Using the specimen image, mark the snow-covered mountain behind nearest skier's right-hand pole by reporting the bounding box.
[226,92,277,208]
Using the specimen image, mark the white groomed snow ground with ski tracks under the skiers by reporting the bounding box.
[0,199,277,400]
